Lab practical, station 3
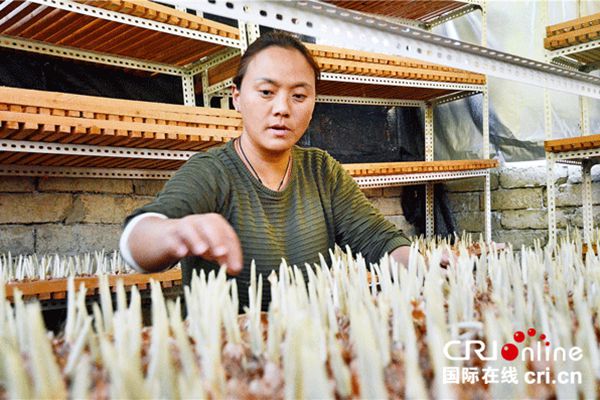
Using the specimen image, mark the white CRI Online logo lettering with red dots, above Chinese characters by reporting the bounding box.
[444,328,583,361]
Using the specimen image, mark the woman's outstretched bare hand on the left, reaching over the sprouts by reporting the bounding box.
[129,213,243,275]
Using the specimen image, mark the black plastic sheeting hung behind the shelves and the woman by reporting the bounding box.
[0,48,456,235]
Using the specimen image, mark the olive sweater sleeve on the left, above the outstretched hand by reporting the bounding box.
[125,153,230,225]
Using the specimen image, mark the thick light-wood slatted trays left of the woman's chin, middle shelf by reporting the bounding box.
[0,87,242,150]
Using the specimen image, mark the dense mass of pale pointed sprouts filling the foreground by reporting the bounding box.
[0,241,600,398]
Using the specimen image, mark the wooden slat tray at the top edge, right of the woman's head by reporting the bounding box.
[326,0,468,22]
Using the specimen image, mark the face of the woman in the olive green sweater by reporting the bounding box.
[233,46,316,153]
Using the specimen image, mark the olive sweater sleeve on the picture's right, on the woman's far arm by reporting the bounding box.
[327,155,410,262]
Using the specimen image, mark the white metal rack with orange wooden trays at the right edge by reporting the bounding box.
[544,9,600,245]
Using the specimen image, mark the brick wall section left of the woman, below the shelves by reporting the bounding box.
[0,176,164,254]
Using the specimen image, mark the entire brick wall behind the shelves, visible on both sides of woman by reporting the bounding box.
[0,165,600,254]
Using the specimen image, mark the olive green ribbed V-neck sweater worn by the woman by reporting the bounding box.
[126,142,410,305]
